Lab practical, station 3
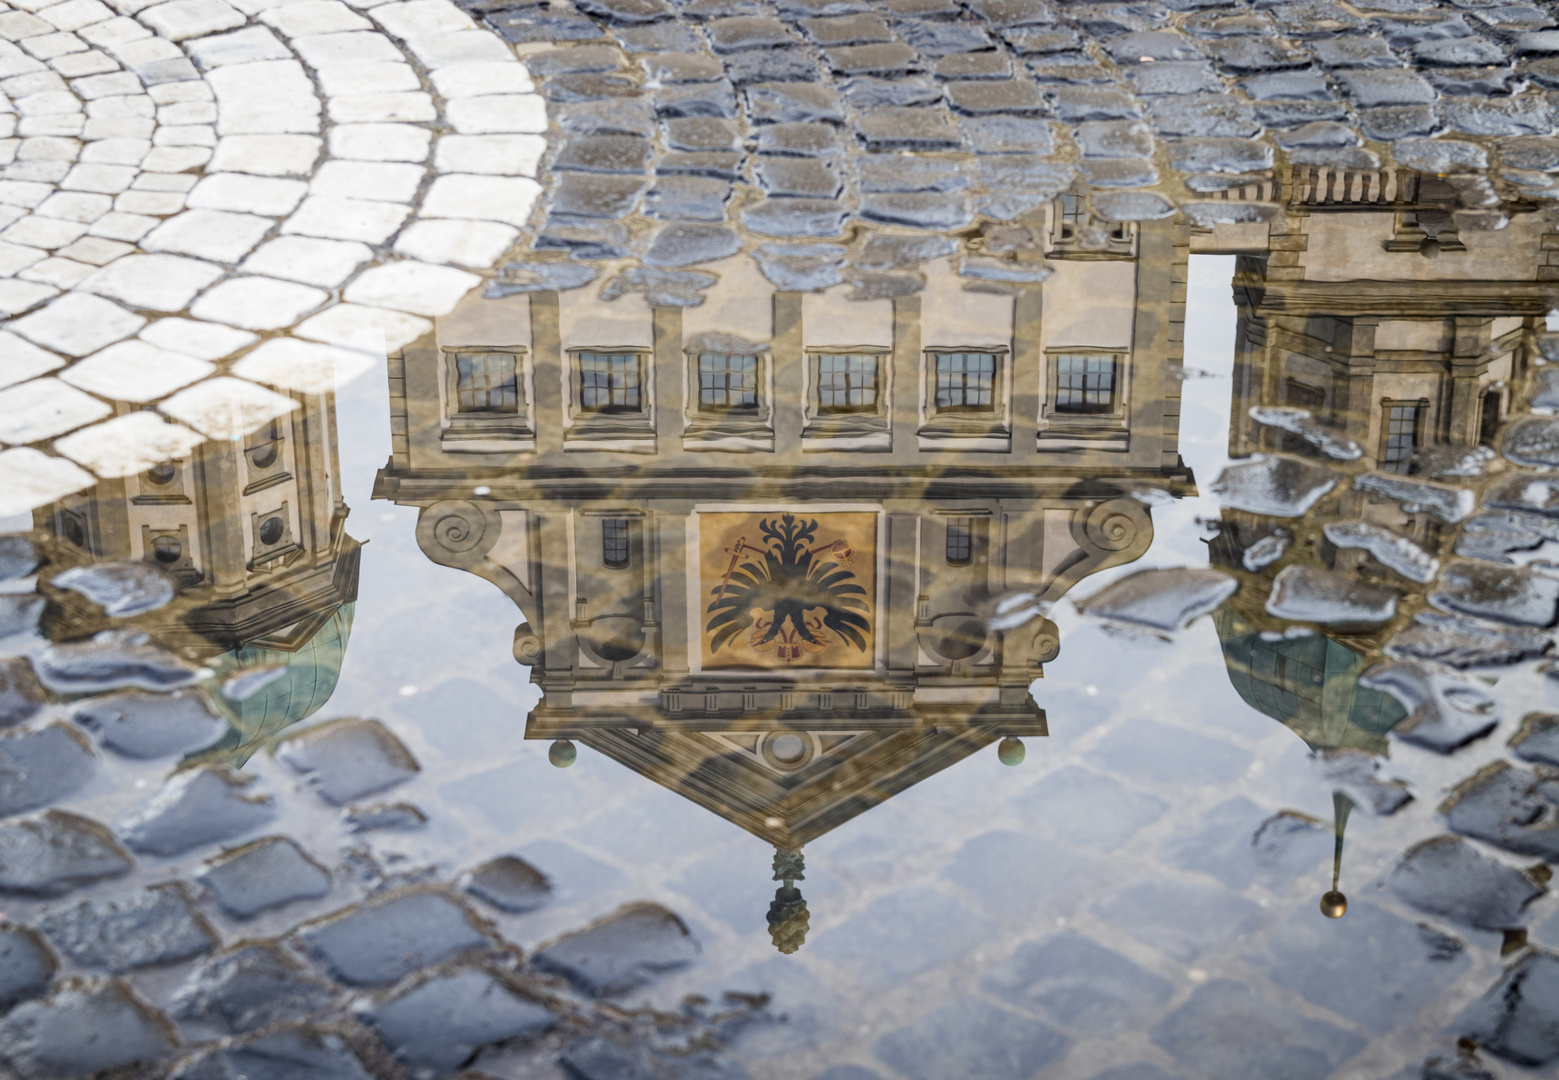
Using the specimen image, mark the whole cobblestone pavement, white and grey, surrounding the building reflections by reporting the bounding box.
[0,0,1559,1080]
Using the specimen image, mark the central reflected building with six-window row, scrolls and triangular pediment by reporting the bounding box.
[376,213,1194,910]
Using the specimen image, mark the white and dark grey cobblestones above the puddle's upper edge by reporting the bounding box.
[0,0,1559,495]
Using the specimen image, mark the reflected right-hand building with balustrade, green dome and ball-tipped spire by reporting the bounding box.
[1193,165,1559,916]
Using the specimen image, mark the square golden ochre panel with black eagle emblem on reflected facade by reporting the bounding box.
[698,511,876,669]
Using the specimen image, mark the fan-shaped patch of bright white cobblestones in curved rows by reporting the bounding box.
[0,0,547,514]
